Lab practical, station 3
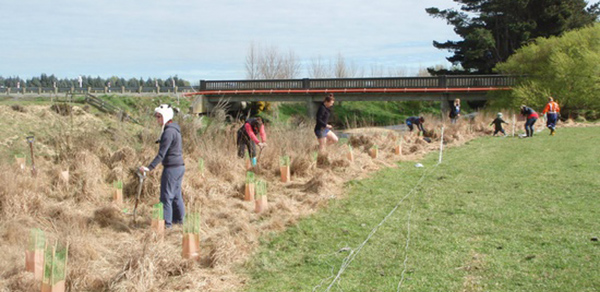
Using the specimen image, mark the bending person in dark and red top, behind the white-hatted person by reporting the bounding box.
[237,117,267,166]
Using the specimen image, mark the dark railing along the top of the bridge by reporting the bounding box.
[200,75,516,91]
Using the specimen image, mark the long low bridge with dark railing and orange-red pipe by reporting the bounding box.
[183,75,517,116]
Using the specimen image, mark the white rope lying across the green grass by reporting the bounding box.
[313,131,444,291]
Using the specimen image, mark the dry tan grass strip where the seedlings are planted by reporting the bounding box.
[0,107,576,291]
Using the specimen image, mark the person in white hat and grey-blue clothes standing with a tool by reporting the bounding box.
[139,104,185,228]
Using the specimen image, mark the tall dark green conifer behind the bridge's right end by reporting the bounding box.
[426,0,600,74]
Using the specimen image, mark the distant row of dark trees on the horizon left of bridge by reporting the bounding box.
[0,74,190,88]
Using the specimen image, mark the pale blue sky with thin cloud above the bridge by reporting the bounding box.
[0,0,459,84]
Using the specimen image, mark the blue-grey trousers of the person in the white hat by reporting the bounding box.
[160,165,185,228]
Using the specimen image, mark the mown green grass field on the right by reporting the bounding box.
[244,127,600,291]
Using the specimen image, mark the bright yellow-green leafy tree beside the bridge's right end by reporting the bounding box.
[497,24,600,111]
